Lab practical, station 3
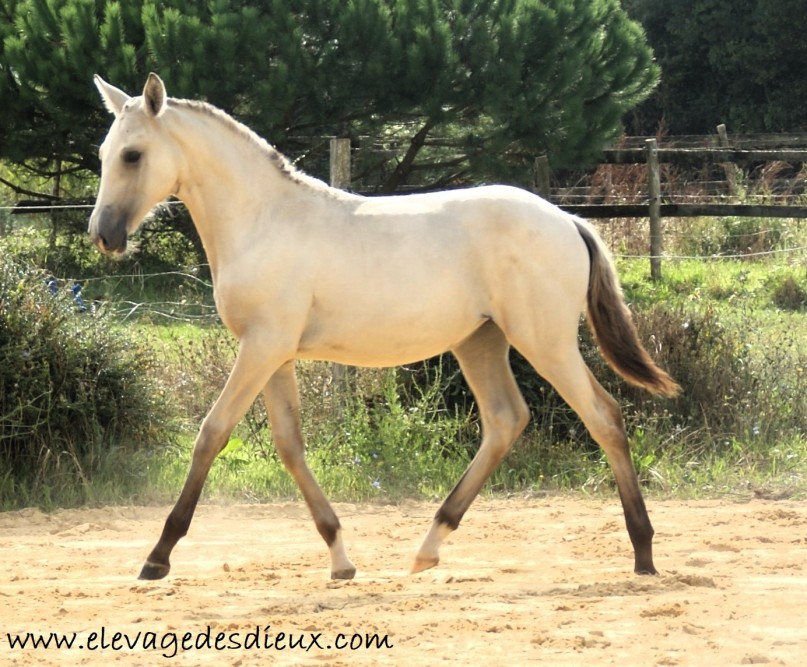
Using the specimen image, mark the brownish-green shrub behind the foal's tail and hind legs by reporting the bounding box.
[400,303,807,462]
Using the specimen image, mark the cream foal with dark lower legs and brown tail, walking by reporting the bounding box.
[89,73,680,580]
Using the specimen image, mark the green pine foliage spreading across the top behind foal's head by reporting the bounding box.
[0,0,657,190]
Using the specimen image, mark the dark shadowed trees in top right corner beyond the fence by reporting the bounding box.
[624,0,807,134]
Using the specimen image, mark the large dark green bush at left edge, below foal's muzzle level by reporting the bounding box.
[0,255,174,503]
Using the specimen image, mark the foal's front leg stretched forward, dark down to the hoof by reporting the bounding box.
[139,339,288,579]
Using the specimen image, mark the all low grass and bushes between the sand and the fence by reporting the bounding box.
[0,220,807,507]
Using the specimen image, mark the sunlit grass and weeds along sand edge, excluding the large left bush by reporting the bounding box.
[0,217,807,507]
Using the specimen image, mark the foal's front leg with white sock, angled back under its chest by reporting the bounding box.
[264,362,356,579]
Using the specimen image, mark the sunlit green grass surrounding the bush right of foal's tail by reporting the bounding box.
[619,253,807,497]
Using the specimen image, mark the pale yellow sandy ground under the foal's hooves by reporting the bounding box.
[0,497,807,666]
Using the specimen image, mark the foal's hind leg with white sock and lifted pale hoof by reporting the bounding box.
[412,322,529,572]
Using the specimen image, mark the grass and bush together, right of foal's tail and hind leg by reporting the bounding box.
[621,259,807,493]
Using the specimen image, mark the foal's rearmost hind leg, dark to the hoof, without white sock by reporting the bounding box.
[514,341,656,574]
